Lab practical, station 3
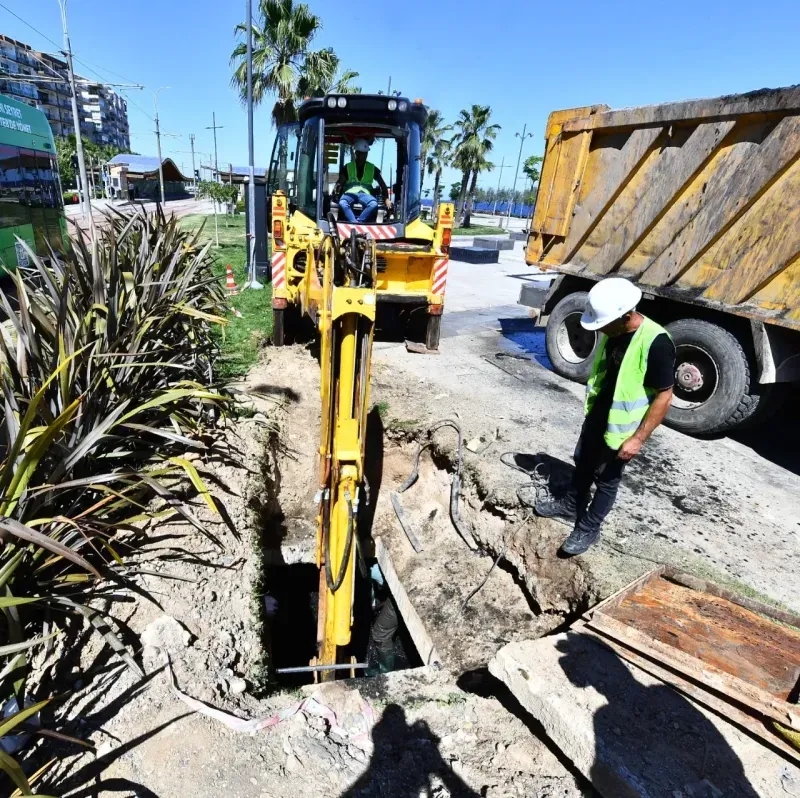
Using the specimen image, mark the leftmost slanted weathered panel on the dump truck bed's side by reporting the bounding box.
[564,127,664,260]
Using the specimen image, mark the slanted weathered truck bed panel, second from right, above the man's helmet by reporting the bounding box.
[642,115,800,285]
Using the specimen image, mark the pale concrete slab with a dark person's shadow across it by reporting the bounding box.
[489,632,800,798]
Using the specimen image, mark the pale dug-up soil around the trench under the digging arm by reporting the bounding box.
[31,347,591,798]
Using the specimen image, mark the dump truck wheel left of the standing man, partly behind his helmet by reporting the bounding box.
[544,291,599,383]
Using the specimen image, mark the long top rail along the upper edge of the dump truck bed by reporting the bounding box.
[564,86,800,133]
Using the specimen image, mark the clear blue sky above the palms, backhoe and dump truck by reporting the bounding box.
[0,0,800,191]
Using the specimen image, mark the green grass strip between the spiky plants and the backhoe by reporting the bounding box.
[181,214,272,380]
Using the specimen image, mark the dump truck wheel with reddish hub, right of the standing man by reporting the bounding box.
[665,319,764,435]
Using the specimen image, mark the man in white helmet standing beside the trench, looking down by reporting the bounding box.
[536,277,675,555]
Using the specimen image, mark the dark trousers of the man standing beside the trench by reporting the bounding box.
[570,424,627,532]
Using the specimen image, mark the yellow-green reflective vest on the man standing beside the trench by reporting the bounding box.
[586,316,669,449]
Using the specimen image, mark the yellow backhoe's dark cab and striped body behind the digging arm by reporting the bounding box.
[267,94,453,349]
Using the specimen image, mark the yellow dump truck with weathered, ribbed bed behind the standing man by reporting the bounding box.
[526,87,800,434]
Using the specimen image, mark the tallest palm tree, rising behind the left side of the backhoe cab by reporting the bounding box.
[231,0,326,125]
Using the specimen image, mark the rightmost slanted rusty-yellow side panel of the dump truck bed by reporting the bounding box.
[704,161,800,305]
